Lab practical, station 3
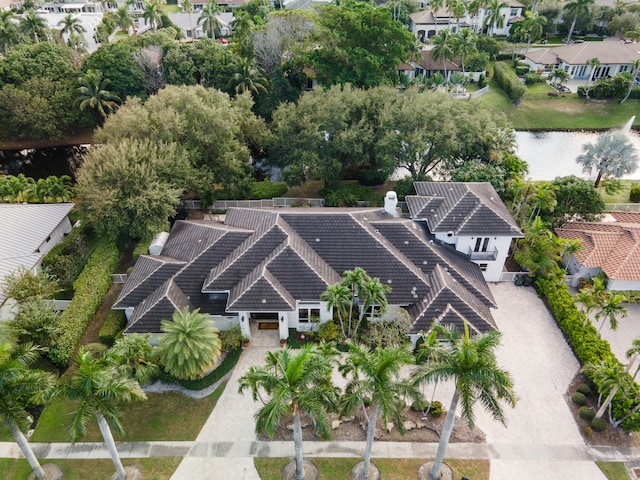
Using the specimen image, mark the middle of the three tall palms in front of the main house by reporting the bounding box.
[339,343,420,478]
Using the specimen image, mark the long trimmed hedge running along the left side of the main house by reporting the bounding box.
[49,240,120,366]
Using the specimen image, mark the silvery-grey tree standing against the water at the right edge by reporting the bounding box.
[576,132,639,188]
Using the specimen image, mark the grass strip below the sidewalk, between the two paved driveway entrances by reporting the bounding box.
[254,458,490,480]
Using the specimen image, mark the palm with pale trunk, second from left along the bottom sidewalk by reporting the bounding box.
[60,349,147,480]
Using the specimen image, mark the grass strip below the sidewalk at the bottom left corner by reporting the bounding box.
[0,457,182,480]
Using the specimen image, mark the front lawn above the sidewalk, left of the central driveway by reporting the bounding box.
[31,383,226,442]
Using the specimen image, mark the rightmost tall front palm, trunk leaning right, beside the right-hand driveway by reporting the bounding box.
[413,322,517,480]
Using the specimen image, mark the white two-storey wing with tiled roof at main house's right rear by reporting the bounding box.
[406,182,524,282]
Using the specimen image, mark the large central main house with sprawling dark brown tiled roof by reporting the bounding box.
[113,183,510,341]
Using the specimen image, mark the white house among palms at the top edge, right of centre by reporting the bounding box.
[409,0,525,42]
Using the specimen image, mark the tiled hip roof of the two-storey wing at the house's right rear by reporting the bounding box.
[407,182,523,238]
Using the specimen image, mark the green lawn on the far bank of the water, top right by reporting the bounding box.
[471,80,640,130]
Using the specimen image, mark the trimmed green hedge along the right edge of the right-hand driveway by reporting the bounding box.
[536,278,640,432]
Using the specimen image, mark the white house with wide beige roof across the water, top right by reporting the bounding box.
[524,41,640,80]
